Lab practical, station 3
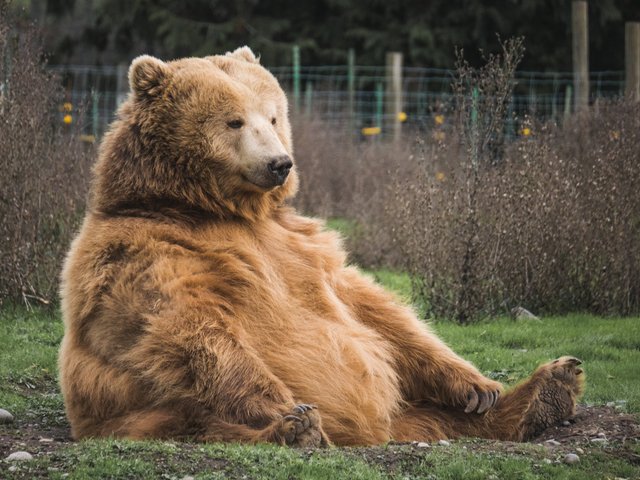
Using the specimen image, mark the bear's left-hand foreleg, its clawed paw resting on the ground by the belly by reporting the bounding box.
[107,316,329,446]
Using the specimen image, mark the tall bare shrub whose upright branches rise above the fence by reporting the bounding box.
[389,39,523,323]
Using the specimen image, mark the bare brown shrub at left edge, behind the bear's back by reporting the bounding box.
[0,2,91,304]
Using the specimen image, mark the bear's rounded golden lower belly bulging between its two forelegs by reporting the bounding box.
[242,298,400,444]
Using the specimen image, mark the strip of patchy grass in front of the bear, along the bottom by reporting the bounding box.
[0,432,640,480]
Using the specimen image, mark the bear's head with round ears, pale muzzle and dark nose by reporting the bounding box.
[92,47,298,219]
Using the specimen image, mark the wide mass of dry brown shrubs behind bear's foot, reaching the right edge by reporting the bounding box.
[387,43,640,323]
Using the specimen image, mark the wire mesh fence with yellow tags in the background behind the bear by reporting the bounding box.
[51,65,624,139]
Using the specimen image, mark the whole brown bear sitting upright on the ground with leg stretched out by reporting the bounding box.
[60,47,582,446]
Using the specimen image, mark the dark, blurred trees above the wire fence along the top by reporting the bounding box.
[8,0,640,71]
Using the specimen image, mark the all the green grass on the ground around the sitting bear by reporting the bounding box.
[0,294,640,479]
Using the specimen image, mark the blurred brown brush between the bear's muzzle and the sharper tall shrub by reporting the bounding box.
[292,117,412,266]
